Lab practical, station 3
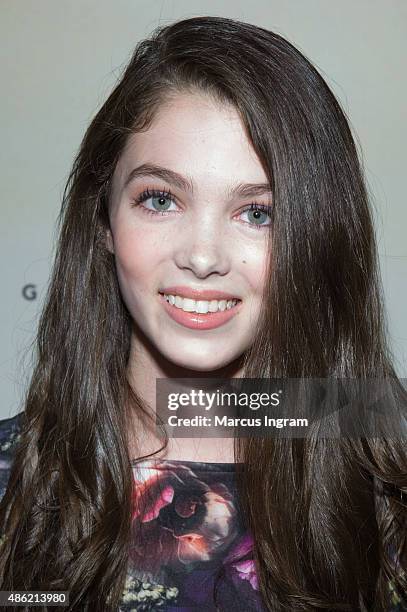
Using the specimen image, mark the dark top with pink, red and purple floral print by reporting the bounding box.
[0,413,407,612]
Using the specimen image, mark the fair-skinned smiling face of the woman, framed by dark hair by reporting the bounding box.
[108,93,271,371]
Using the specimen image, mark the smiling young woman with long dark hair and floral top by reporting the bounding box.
[0,17,407,612]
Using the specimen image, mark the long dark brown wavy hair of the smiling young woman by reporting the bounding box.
[0,17,407,612]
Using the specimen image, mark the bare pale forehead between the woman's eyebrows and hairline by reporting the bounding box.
[114,94,266,186]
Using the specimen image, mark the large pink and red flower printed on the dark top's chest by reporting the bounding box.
[130,461,236,570]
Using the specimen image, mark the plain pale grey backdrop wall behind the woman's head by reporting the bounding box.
[0,0,407,418]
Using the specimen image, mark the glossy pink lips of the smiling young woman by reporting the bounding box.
[159,287,242,329]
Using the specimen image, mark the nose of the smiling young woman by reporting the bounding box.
[174,214,232,278]
